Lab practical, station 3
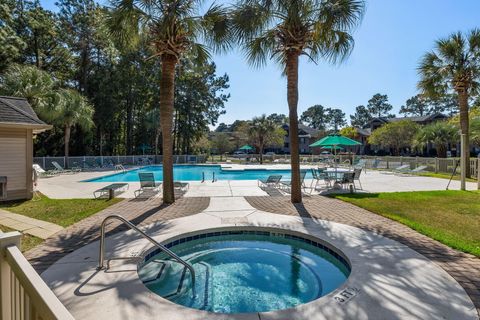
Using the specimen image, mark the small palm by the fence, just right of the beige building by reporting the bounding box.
[54,89,94,163]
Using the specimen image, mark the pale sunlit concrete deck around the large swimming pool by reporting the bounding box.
[38,164,477,199]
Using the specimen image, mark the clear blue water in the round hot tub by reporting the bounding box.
[139,231,350,313]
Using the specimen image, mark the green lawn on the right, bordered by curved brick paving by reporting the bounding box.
[333,191,480,257]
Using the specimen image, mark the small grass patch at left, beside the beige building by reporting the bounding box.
[0,195,122,227]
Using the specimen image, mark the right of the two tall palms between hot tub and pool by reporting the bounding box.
[232,0,365,203]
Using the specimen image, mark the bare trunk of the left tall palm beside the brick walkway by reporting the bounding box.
[160,55,177,204]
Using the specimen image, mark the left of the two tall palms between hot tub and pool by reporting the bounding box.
[108,0,230,203]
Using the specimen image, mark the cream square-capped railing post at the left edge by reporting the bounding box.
[0,231,22,319]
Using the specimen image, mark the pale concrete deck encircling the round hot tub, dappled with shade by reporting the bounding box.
[42,197,478,320]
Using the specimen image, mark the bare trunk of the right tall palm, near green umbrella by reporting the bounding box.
[286,52,302,203]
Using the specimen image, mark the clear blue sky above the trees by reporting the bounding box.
[41,0,480,123]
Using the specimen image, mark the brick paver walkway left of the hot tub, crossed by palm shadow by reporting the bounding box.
[25,197,210,273]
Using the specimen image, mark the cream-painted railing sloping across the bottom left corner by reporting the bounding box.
[0,232,74,320]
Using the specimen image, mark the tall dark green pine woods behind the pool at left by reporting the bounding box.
[0,0,229,156]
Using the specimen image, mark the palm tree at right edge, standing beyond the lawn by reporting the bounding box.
[418,29,480,177]
